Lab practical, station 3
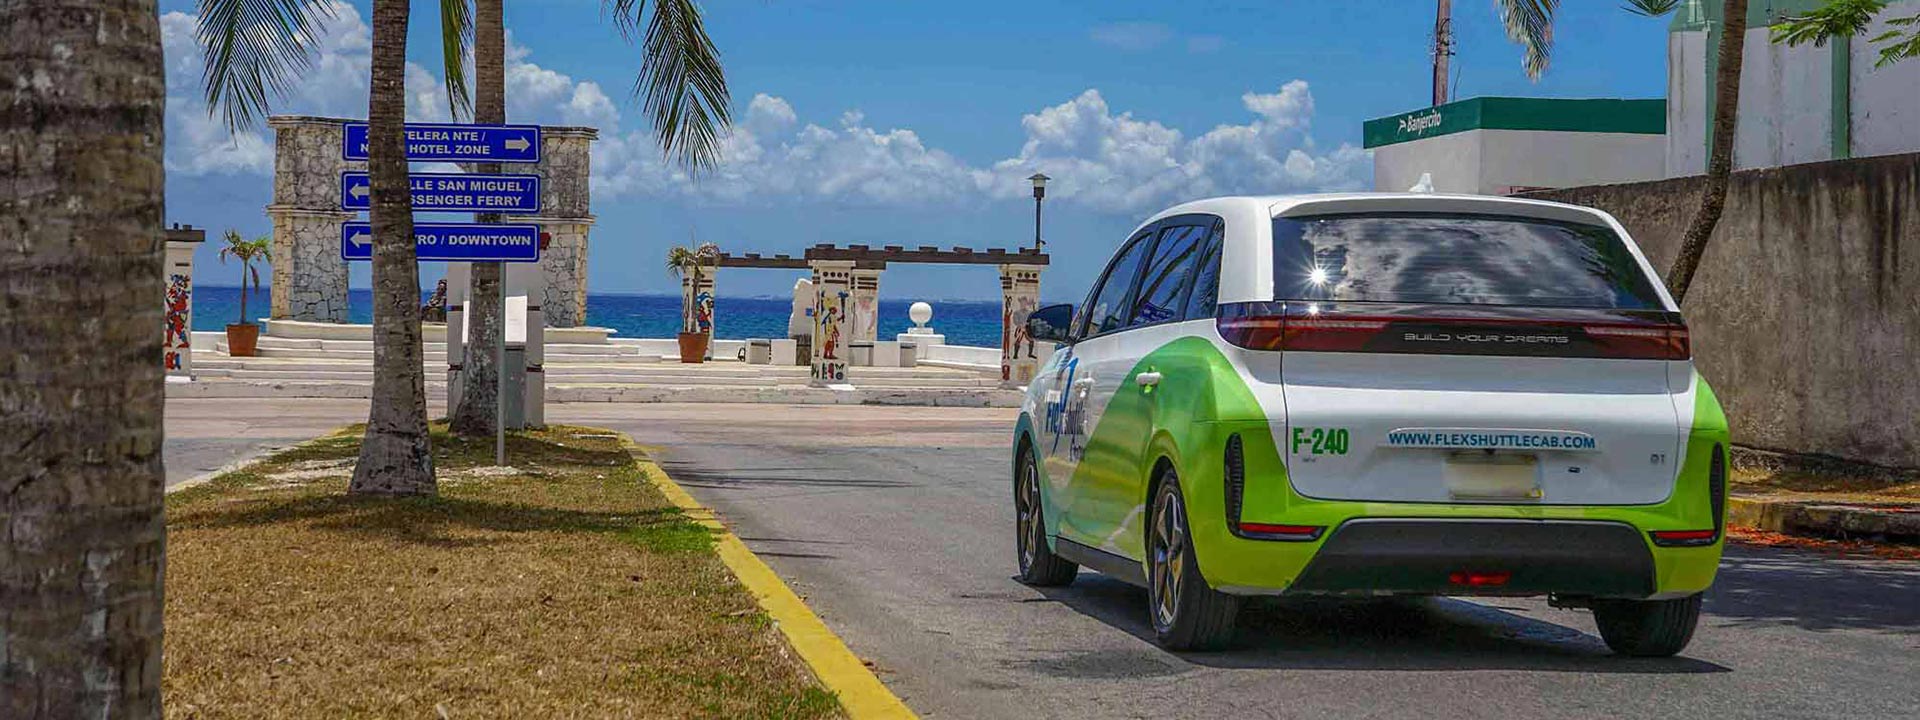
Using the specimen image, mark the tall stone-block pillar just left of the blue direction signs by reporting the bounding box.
[267,115,367,323]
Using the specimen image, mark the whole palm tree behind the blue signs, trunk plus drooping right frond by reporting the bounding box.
[453,0,732,436]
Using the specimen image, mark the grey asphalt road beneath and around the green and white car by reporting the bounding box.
[564,405,1920,720]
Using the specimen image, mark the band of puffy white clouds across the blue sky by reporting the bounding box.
[161,9,1369,213]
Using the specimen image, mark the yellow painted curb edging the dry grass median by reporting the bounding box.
[622,434,916,720]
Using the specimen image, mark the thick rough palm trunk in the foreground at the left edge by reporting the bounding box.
[0,0,165,718]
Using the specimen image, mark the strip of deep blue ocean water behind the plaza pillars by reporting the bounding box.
[194,284,1000,348]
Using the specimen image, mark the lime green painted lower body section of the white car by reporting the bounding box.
[1016,336,1728,597]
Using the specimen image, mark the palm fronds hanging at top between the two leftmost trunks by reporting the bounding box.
[198,0,334,131]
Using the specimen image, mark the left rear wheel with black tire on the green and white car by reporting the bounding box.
[1146,470,1240,651]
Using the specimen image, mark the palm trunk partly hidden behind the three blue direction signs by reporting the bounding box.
[451,0,507,436]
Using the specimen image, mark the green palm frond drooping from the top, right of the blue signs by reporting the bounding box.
[607,0,733,171]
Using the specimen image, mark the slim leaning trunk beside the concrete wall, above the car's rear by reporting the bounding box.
[1667,0,1747,303]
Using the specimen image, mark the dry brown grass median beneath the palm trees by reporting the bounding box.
[165,426,839,718]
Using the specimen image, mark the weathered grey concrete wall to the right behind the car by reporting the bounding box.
[1532,156,1920,467]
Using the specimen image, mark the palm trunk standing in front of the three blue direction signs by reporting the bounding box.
[348,0,436,495]
